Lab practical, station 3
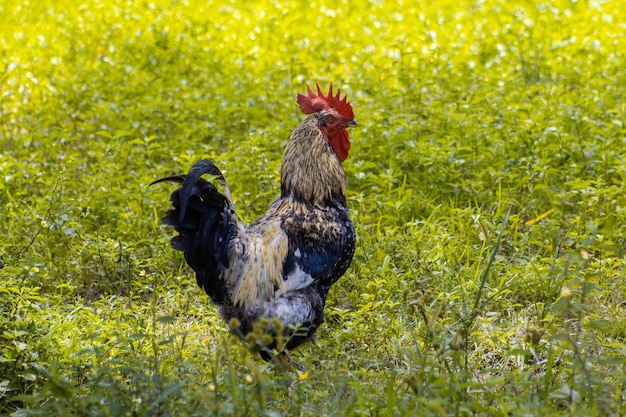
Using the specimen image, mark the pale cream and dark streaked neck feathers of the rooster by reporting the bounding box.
[281,114,346,206]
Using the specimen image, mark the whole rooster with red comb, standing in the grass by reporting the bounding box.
[154,84,356,366]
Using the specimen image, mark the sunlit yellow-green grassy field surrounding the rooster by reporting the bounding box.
[0,0,626,416]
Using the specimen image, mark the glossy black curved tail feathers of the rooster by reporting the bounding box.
[151,160,237,302]
